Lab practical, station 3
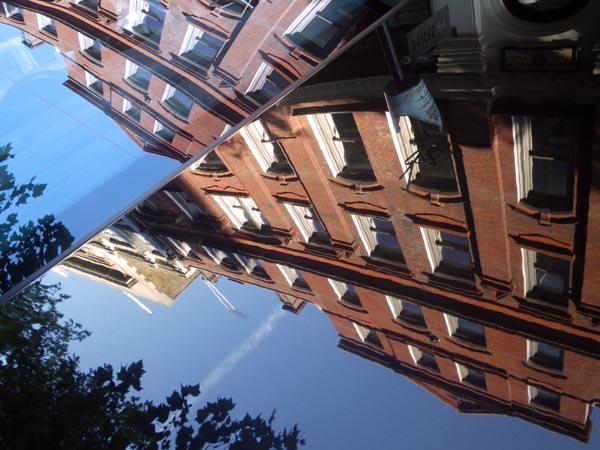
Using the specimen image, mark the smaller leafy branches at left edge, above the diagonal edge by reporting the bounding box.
[0,144,73,294]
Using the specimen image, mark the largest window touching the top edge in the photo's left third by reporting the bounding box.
[123,0,167,45]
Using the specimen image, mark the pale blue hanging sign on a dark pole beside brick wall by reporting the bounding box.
[384,78,442,128]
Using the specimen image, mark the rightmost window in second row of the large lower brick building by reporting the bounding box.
[521,248,571,309]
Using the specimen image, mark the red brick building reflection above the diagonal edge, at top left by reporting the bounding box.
[0,0,395,162]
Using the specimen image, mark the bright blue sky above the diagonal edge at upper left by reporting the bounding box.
[0,25,179,238]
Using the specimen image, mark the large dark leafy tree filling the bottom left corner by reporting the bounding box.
[0,281,304,450]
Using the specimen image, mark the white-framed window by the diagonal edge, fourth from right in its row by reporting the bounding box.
[240,120,294,175]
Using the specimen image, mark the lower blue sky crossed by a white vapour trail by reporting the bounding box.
[48,268,600,450]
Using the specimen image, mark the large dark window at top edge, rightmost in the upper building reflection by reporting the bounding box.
[285,0,365,57]
